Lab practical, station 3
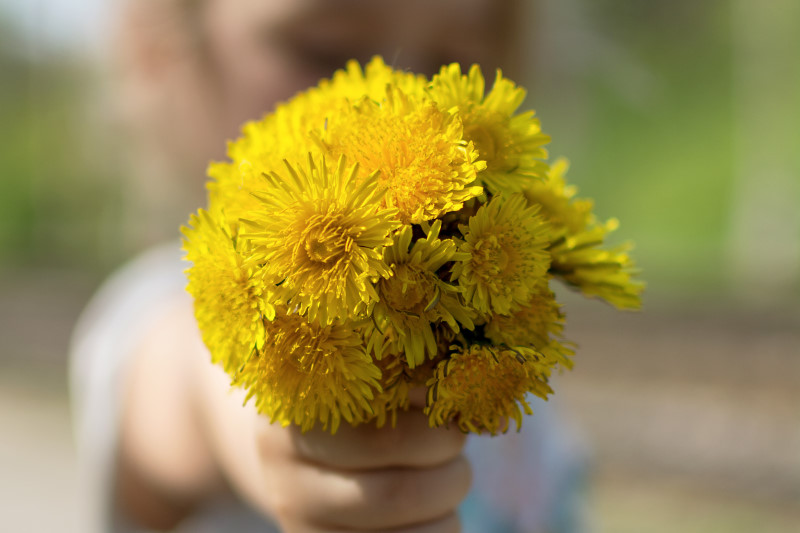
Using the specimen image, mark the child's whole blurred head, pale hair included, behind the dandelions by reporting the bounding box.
[123,0,513,201]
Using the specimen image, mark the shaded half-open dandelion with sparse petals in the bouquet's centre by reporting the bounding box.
[372,220,473,368]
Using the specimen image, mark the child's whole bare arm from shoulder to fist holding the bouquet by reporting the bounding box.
[118,298,470,533]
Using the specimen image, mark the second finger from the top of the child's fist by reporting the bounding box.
[274,457,471,531]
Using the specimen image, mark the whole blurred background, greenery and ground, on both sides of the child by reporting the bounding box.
[0,0,800,533]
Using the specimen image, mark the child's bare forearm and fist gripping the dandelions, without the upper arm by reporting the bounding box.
[191,330,471,533]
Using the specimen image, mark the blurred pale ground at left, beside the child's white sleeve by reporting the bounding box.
[0,271,92,533]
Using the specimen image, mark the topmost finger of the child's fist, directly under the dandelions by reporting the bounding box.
[263,409,466,470]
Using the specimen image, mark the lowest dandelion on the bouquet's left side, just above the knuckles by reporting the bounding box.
[233,308,381,433]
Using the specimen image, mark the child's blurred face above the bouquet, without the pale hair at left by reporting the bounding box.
[201,0,508,152]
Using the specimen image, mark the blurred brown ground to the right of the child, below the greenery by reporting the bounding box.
[555,299,800,533]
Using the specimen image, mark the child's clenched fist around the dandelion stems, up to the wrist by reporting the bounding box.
[256,402,470,533]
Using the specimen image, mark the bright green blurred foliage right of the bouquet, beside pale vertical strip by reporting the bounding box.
[535,0,734,291]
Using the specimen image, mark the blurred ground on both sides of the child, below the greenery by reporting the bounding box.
[0,271,800,533]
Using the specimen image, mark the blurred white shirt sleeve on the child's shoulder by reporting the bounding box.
[70,242,189,533]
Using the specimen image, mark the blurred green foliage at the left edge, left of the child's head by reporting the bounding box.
[0,18,121,272]
